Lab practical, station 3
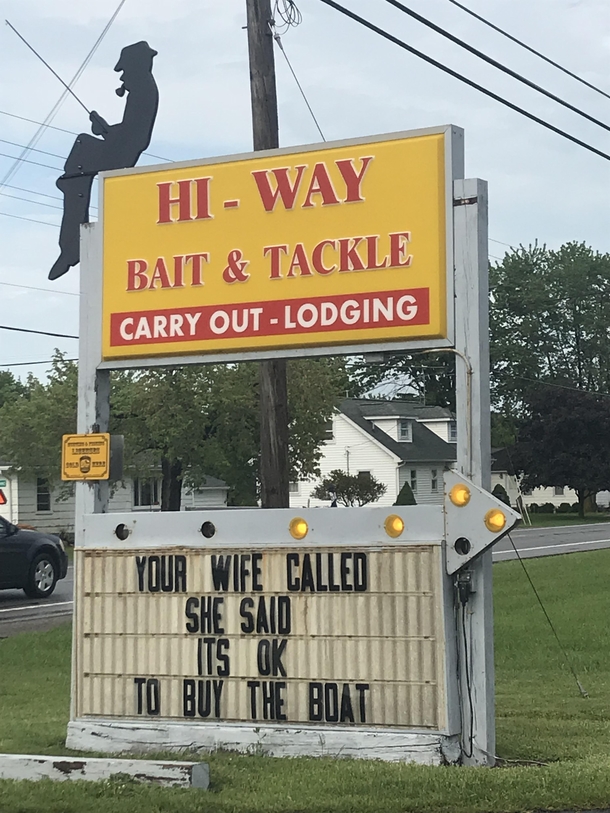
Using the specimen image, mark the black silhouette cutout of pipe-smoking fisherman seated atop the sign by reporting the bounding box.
[49,42,159,279]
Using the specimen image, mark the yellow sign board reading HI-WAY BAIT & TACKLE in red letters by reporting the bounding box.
[101,127,454,360]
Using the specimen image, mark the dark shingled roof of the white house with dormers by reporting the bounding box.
[339,398,455,463]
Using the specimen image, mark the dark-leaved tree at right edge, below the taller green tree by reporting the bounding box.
[513,386,610,516]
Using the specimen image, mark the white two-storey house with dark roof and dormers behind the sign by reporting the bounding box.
[290,399,456,508]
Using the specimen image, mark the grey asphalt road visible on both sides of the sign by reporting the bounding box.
[0,522,610,638]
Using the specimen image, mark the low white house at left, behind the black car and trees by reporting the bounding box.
[0,465,229,534]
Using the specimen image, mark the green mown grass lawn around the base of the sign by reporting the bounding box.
[0,550,610,813]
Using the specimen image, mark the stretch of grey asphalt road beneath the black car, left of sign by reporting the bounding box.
[0,565,74,638]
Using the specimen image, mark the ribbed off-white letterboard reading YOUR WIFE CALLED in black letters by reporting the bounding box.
[75,543,446,730]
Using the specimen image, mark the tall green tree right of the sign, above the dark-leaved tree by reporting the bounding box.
[490,238,610,410]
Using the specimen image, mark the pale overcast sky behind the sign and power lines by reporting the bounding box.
[0,0,610,377]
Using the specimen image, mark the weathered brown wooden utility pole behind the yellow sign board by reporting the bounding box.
[246,0,289,508]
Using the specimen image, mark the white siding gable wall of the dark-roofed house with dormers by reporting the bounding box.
[290,413,398,508]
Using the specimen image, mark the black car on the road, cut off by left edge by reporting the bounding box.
[0,517,68,598]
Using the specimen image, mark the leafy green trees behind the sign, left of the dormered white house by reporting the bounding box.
[0,354,347,510]
